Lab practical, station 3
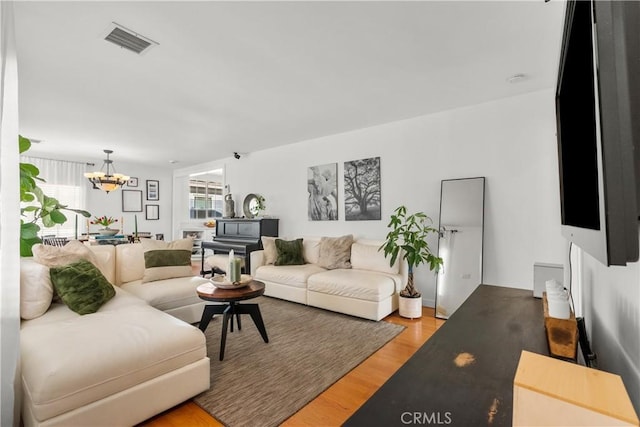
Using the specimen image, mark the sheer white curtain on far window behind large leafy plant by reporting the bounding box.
[20,156,87,238]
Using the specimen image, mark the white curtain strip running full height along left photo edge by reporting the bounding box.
[0,1,22,426]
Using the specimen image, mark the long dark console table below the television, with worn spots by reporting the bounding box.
[344,285,548,427]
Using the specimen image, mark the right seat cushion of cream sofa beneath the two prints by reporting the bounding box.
[307,269,401,302]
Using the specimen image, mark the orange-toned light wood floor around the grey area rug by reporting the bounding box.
[142,307,444,427]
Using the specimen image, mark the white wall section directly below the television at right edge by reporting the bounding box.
[572,246,640,414]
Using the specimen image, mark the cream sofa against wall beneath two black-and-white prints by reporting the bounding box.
[251,237,407,320]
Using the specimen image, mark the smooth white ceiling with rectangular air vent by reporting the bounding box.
[14,0,564,167]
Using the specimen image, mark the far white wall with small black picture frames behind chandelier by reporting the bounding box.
[87,158,173,240]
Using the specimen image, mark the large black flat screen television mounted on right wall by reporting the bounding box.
[556,0,640,265]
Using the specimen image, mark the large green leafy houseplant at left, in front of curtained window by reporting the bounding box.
[18,136,91,257]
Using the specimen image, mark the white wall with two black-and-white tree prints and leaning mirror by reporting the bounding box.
[180,90,564,306]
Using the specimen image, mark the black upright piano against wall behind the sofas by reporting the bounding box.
[200,218,278,276]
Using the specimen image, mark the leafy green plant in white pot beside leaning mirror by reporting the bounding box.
[380,206,442,319]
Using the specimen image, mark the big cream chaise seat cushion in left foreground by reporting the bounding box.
[20,288,206,420]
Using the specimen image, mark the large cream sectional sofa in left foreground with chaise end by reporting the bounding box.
[20,244,210,426]
